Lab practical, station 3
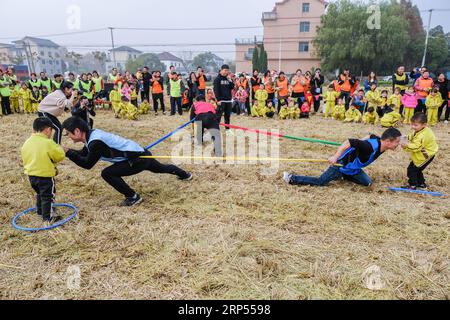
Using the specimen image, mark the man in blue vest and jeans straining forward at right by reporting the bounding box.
[283,128,402,187]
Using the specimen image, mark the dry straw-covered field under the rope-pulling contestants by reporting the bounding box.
[0,111,450,299]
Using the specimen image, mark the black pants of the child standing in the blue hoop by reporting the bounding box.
[29,176,56,221]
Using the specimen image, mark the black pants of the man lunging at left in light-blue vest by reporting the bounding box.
[102,152,189,198]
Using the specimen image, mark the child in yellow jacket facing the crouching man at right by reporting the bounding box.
[402,112,439,190]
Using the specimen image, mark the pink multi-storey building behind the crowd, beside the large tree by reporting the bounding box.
[236,0,327,73]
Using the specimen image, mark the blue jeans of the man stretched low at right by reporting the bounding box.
[290,166,372,187]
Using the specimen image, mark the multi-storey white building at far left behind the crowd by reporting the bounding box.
[13,37,67,76]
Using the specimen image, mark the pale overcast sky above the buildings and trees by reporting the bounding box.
[0,0,450,58]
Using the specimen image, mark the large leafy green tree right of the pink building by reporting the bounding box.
[314,0,411,74]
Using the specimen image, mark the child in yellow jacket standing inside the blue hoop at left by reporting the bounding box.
[21,117,65,223]
